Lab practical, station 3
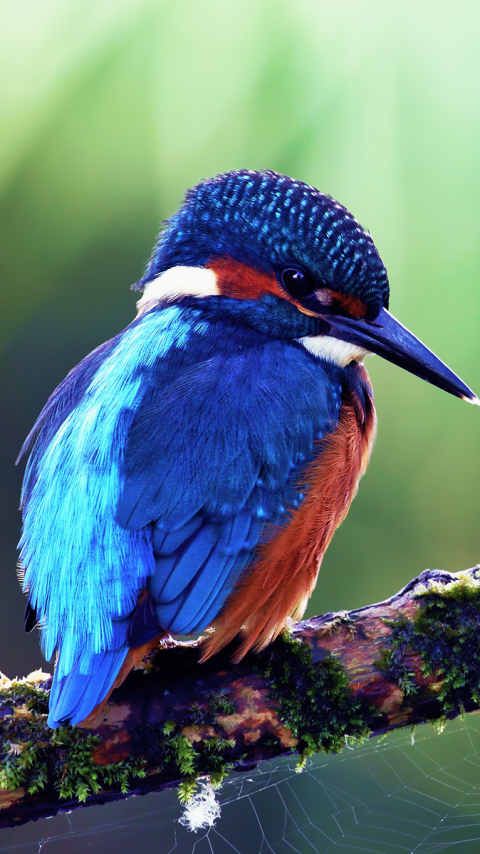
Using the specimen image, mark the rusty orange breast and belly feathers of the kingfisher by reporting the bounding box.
[202,365,377,661]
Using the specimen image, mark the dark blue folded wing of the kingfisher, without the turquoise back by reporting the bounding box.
[117,331,340,645]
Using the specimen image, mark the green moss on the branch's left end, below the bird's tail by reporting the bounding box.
[0,679,235,802]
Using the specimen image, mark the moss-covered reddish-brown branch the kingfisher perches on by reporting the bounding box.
[0,567,480,827]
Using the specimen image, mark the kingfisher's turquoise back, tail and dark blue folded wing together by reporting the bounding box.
[21,306,341,726]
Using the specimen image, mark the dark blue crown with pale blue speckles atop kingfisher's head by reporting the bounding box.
[134,169,389,316]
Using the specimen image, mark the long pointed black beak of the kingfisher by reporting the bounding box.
[319,308,480,405]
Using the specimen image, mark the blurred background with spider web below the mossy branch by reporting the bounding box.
[0,715,480,854]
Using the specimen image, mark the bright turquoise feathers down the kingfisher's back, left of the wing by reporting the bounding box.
[21,307,199,717]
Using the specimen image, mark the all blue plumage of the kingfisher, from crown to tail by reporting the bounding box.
[16,170,388,726]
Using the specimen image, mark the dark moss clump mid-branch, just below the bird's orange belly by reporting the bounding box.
[255,632,378,770]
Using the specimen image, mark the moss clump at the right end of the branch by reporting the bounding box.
[375,573,480,716]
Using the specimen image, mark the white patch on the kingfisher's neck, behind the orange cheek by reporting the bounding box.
[137,266,220,316]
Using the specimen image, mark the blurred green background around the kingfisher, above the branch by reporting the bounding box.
[0,0,480,852]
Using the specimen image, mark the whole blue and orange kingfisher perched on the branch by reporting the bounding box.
[19,169,480,728]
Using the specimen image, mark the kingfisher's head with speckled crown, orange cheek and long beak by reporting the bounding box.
[135,170,480,403]
